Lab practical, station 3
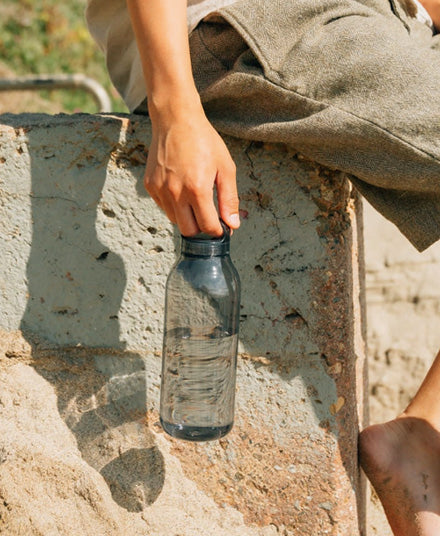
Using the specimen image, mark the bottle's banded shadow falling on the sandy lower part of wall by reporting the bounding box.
[32,344,165,512]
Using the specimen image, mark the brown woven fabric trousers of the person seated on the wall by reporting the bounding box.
[181,0,440,250]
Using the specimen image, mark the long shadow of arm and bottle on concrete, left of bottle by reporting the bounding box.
[2,115,164,512]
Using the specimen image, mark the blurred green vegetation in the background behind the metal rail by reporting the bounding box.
[0,0,127,113]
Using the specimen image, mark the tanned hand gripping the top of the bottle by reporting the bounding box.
[144,107,240,236]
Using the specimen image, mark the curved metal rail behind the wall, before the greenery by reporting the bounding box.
[0,74,112,112]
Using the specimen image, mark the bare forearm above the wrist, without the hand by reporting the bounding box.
[127,0,201,120]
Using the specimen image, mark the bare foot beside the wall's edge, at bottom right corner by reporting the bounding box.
[359,415,440,536]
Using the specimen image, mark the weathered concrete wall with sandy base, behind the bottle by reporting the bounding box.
[0,115,365,536]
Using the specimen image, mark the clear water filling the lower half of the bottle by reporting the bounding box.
[161,326,238,441]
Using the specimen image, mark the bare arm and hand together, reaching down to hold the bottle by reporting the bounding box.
[127,0,240,236]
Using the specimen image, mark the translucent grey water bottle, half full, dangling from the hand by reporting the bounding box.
[160,222,240,441]
